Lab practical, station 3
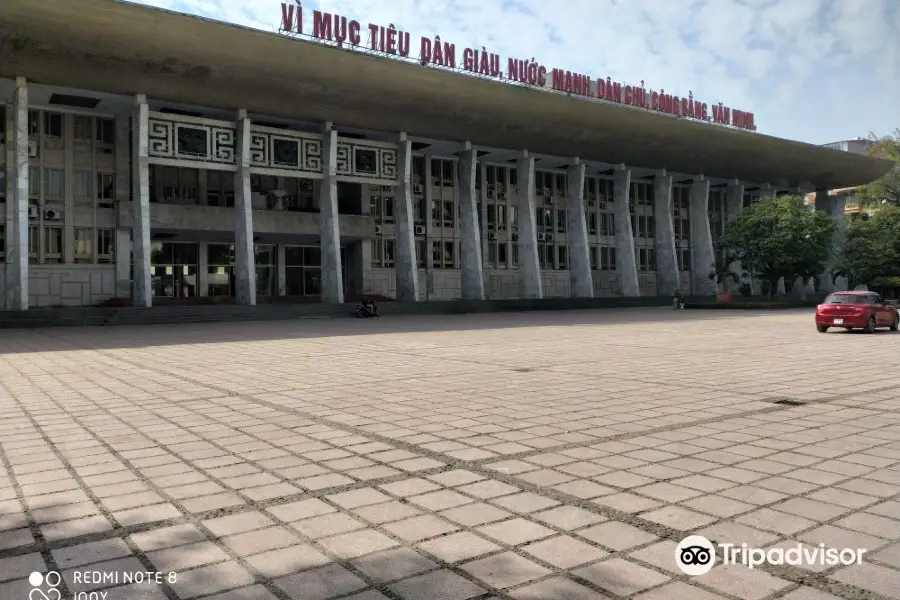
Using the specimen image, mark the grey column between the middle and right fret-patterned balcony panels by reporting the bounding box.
[319,123,342,304]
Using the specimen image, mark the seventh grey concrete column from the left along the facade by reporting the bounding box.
[516,150,544,299]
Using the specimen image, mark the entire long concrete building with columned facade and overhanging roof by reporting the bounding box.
[0,0,890,310]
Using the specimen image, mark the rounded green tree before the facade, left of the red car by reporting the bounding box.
[719,196,837,295]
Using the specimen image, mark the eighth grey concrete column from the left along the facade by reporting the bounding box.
[566,158,594,298]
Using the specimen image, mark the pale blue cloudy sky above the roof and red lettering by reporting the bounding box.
[132,0,900,144]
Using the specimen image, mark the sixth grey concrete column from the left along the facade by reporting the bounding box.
[459,144,484,300]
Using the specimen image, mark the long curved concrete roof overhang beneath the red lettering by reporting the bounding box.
[0,0,893,189]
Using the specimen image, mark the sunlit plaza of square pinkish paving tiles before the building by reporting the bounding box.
[0,309,900,600]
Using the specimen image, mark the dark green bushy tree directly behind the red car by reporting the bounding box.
[834,205,900,288]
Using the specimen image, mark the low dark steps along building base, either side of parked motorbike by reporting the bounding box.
[0,296,671,329]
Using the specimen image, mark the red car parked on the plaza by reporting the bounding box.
[816,292,900,333]
